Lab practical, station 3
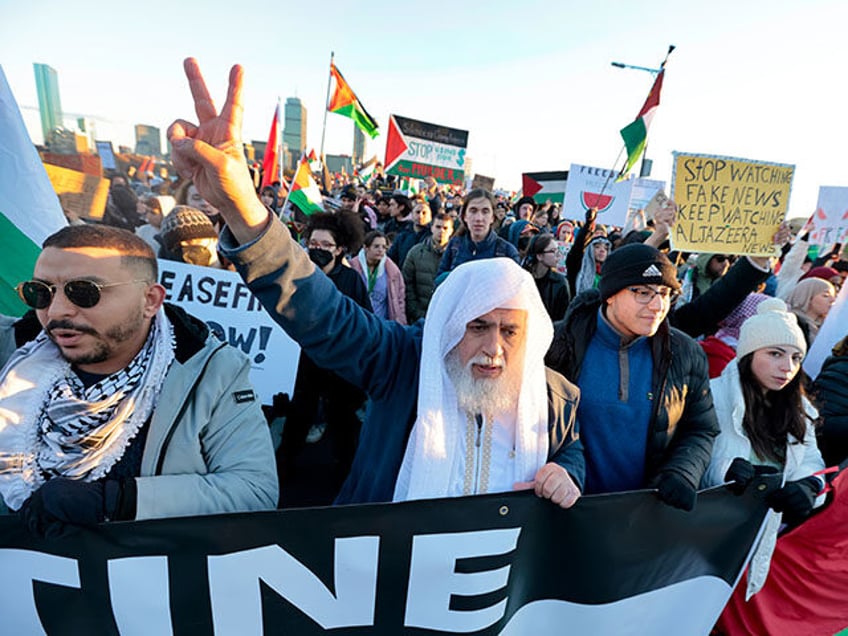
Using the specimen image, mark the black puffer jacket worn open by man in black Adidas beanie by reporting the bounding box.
[545,289,719,488]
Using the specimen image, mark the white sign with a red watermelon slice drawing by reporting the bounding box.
[562,163,633,227]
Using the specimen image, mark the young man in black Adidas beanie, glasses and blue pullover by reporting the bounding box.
[546,243,718,510]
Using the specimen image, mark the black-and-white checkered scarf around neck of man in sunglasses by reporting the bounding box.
[0,309,174,510]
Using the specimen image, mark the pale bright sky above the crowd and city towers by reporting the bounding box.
[0,0,848,217]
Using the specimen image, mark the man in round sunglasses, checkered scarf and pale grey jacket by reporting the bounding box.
[0,225,278,535]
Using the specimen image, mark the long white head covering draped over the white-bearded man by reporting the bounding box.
[394,258,553,501]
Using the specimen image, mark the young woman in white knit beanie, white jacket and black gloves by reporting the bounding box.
[702,298,824,592]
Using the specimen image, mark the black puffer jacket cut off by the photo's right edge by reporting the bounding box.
[812,338,848,466]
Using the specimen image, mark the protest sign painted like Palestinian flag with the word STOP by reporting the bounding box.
[384,115,468,185]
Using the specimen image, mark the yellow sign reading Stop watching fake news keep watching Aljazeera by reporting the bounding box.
[671,152,795,256]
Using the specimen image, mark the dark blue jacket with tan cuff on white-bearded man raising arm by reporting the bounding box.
[220,219,585,503]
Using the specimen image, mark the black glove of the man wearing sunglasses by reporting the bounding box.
[20,477,136,537]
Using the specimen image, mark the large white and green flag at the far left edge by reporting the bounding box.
[0,67,68,316]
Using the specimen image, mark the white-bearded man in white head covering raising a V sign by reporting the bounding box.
[169,59,583,507]
